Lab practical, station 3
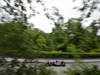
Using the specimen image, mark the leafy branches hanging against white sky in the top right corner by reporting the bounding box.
[73,0,100,23]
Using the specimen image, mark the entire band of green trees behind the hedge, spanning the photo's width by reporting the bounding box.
[0,19,100,58]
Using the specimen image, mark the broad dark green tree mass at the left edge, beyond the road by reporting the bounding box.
[0,22,32,56]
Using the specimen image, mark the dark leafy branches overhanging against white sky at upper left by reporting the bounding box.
[0,0,61,23]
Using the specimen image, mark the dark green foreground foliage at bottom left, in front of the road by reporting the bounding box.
[0,59,56,75]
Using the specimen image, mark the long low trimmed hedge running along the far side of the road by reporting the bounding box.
[33,51,100,59]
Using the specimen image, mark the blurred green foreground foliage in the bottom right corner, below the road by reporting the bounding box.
[66,63,100,75]
